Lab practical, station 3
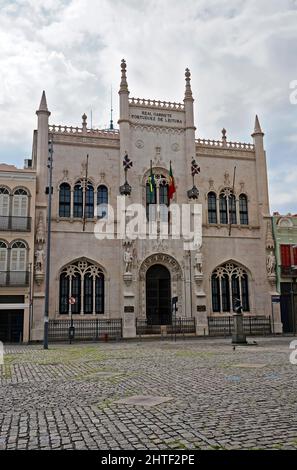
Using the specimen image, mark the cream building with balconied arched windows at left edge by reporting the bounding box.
[0,164,36,342]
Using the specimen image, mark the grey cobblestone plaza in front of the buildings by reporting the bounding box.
[0,337,297,450]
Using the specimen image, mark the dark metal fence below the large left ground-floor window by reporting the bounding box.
[49,318,123,341]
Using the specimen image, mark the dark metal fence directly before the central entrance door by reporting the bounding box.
[136,318,196,336]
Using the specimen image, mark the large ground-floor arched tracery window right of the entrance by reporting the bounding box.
[211,263,250,312]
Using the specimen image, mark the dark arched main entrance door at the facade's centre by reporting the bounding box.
[146,264,171,325]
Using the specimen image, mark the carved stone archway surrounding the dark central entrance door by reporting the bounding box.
[139,253,184,318]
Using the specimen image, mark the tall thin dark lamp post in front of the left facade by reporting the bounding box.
[43,136,54,349]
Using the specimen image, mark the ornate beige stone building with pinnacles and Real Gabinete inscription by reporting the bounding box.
[27,61,282,340]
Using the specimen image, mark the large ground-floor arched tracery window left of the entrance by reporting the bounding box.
[59,260,104,315]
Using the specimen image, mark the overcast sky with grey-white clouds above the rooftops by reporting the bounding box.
[0,0,297,213]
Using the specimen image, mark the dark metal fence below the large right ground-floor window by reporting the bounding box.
[208,316,271,336]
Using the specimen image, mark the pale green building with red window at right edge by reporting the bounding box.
[272,212,297,333]
